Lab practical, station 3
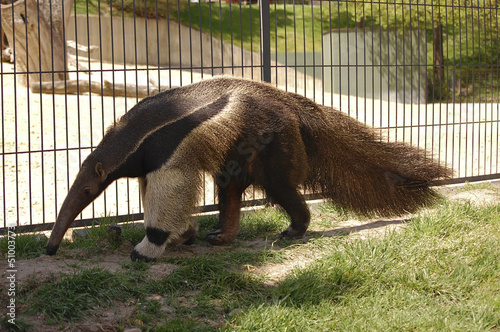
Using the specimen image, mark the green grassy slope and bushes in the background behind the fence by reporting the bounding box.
[75,0,500,102]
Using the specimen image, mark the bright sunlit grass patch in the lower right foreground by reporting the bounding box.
[234,204,500,331]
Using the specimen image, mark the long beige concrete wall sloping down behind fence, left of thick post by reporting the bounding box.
[67,15,260,77]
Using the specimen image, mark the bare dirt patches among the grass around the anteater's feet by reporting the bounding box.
[0,180,500,331]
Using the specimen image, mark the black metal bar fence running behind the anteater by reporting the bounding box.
[0,0,500,229]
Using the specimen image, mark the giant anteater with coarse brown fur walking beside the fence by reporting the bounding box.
[48,77,452,260]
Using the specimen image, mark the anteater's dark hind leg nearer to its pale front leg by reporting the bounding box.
[207,176,251,245]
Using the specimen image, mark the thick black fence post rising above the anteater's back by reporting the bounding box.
[260,0,271,82]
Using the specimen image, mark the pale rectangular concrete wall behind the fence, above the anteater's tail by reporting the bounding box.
[323,29,427,103]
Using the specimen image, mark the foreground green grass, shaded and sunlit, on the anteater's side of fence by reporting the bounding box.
[2,184,500,331]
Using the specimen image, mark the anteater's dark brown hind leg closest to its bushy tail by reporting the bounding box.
[265,185,311,239]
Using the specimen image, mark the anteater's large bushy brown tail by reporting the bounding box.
[304,107,453,217]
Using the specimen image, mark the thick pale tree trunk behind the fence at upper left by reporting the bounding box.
[1,0,73,86]
